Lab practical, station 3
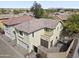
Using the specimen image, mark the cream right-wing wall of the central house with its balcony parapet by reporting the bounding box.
[42,22,63,48]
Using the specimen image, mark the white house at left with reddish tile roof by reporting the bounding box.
[2,16,32,40]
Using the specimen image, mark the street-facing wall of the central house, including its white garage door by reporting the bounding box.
[16,31,29,52]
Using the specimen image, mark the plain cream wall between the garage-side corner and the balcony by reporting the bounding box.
[29,29,44,50]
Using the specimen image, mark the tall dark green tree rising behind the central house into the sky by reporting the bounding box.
[31,1,44,18]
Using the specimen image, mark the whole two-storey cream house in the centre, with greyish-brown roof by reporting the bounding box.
[14,19,63,53]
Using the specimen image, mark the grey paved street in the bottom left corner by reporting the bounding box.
[0,35,23,58]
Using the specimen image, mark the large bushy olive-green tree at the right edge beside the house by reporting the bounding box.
[65,14,79,33]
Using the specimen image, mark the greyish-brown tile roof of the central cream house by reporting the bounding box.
[14,19,59,33]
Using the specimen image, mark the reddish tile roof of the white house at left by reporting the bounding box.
[3,16,32,26]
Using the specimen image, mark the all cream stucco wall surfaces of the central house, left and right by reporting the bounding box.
[16,22,63,52]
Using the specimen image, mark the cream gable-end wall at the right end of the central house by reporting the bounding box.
[50,22,63,45]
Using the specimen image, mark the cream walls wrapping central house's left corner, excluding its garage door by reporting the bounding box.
[16,29,44,52]
